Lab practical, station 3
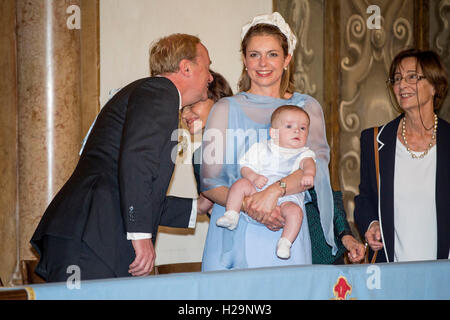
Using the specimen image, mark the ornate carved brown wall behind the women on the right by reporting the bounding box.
[274,0,450,235]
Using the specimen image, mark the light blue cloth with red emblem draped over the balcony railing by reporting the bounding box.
[4,260,450,300]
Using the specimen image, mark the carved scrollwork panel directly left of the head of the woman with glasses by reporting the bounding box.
[338,0,414,221]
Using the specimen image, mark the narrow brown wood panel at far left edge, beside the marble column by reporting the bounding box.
[0,1,18,285]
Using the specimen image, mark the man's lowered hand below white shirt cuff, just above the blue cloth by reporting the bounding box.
[128,239,156,276]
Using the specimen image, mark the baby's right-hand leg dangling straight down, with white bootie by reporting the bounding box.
[277,201,303,259]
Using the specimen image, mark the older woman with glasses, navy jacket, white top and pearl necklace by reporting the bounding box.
[355,49,450,262]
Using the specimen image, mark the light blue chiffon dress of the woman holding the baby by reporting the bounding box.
[200,92,337,271]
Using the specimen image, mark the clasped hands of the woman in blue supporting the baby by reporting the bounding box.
[243,184,285,231]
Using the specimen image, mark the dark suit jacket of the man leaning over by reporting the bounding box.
[31,77,190,276]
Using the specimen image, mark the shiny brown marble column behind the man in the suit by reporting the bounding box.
[16,0,82,260]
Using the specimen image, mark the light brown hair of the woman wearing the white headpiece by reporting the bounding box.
[238,23,295,98]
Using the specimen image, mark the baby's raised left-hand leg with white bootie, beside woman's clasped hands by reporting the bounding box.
[216,178,256,230]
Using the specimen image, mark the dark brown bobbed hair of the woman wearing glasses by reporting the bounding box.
[389,49,448,112]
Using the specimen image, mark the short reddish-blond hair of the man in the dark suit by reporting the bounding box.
[150,33,200,76]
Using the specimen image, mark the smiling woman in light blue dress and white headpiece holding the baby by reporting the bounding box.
[201,12,337,271]
